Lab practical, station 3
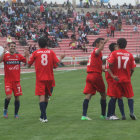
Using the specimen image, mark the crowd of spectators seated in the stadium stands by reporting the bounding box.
[0,0,140,51]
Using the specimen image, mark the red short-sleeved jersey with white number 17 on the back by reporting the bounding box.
[108,49,136,82]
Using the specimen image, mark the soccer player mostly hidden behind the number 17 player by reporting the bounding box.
[105,43,126,120]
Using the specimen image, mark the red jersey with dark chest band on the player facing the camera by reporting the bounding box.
[3,53,26,82]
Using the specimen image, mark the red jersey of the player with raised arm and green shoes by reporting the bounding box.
[87,48,102,73]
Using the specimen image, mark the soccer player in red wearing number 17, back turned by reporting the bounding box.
[108,38,137,120]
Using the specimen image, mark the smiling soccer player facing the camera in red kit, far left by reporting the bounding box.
[0,42,26,118]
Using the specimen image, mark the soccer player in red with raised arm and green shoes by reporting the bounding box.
[81,38,107,120]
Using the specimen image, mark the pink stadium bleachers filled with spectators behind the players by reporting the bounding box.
[0,1,140,64]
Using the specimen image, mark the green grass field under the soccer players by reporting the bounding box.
[0,68,140,140]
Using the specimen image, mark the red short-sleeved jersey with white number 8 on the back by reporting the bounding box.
[28,48,59,81]
